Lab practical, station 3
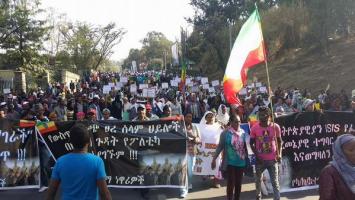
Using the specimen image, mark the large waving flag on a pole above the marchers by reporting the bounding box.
[223,9,266,104]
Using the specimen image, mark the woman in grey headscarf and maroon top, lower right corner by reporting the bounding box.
[319,134,355,200]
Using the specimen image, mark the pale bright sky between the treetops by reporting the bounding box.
[41,0,193,60]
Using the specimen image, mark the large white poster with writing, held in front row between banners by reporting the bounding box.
[193,124,223,176]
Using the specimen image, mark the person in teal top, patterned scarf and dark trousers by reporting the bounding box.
[211,115,248,200]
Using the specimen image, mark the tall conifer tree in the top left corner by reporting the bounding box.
[0,0,48,71]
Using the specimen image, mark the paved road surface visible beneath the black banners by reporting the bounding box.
[0,177,319,200]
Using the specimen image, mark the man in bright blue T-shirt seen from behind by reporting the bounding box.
[47,125,111,200]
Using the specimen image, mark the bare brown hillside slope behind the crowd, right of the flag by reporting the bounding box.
[251,37,355,96]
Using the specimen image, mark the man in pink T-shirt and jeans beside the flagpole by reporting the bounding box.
[250,106,282,200]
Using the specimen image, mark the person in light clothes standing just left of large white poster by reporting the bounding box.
[180,113,201,198]
